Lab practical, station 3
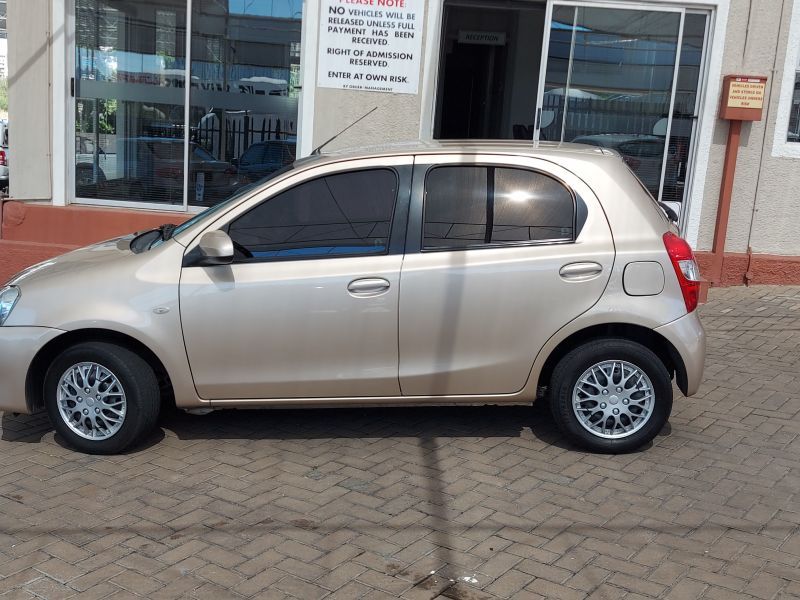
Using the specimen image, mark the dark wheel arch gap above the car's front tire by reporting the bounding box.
[25,328,175,413]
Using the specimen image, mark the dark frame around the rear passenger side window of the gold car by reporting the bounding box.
[419,161,580,253]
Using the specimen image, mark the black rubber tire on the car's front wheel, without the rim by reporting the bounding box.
[44,342,161,454]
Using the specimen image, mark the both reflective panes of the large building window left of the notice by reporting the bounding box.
[75,0,302,206]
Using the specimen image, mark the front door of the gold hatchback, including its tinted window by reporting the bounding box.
[180,161,410,400]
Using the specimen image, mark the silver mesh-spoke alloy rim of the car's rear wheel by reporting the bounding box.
[572,360,655,439]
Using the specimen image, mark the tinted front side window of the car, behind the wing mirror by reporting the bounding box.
[228,169,397,260]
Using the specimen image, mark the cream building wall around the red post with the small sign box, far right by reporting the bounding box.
[698,0,800,256]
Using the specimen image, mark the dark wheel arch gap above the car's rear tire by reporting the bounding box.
[537,323,688,394]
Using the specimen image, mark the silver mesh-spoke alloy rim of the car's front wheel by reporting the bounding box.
[57,362,128,441]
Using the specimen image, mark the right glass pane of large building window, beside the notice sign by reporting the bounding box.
[188,0,303,206]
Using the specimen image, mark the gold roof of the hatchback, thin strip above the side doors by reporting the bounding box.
[300,140,616,168]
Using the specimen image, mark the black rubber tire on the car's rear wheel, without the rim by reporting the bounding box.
[549,338,672,454]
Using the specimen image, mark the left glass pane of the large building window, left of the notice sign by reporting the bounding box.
[75,0,186,204]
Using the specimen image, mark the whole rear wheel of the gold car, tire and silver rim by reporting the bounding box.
[550,339,672,453]
